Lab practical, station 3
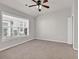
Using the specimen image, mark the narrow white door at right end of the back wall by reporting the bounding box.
[68,17,73,44]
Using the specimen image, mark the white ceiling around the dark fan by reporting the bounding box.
[0,0,72,16]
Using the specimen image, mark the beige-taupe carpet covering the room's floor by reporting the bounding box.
[0,40,77,59]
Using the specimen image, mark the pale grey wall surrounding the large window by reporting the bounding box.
[0,4,35,49]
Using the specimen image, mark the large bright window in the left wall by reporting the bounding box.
[2,15,29,38]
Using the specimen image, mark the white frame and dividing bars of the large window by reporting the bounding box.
[2,14,29,39]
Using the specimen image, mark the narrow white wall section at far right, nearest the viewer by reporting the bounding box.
[72,0,78,50]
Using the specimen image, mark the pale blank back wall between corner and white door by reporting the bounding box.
[36,8,71,43]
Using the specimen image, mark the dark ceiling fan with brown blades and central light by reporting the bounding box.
[25,0,49,12]
